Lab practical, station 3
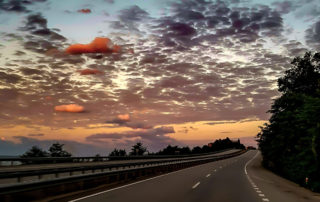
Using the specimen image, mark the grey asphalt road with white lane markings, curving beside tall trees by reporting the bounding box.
[64,151,320,202]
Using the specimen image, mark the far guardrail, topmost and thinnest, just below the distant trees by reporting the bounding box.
[0,148,233,167]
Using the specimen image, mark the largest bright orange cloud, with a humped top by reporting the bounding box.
[66,37,121,54]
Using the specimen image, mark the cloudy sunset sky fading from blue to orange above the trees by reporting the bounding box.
[0,0,320,156]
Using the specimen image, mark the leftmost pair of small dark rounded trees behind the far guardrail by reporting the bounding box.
[21,142,72,158]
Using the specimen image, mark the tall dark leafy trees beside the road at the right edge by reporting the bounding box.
[258,52,320,192]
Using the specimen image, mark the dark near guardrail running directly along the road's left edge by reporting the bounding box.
[0,150,246,202]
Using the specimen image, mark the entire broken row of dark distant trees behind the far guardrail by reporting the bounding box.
[21,137,245,157]
